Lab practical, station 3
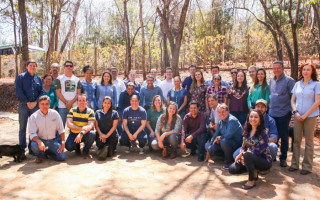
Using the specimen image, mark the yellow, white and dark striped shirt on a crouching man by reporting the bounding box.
[67,107,95,133]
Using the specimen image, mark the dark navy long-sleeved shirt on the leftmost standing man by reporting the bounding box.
[16,72,43,103]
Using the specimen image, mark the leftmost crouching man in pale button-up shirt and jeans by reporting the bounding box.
[27,95,66,163]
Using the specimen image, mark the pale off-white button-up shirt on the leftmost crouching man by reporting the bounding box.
[27,109,64,140]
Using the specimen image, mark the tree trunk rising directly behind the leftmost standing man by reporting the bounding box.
[18,0,29,67]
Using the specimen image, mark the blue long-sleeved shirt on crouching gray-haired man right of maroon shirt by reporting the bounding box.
[211,114,242,145]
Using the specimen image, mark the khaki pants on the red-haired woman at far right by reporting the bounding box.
[291,117,317,172]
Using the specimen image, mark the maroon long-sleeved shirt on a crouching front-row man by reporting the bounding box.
[181,112,207,141]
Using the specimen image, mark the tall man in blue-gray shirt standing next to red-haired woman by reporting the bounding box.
[269,61,295,167]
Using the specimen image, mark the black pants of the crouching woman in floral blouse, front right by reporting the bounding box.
[243,152,271,181]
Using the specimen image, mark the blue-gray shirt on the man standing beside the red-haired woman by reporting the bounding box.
[269,73,295,117]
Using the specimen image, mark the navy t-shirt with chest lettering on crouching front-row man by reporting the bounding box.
[122,106,147,132]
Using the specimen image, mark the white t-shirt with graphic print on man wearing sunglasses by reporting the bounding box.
[54,75,81,108]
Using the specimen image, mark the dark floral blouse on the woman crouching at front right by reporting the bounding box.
[240,132,272,165]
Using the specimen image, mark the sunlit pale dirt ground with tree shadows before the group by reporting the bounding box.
[0,114,320,200]
